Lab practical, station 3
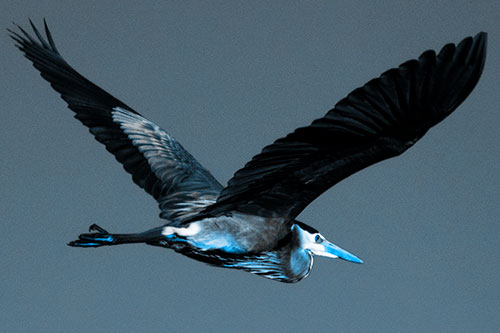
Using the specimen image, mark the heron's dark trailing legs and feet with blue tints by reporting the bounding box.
[68,224,161,247]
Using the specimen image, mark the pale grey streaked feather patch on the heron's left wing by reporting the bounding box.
[111,107,222,224]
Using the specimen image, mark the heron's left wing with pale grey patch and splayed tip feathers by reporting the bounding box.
[9,21,222,223]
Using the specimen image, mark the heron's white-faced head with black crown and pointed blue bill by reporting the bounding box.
[293,221,363,264]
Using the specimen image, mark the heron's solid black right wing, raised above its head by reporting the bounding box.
[204,32,487,221]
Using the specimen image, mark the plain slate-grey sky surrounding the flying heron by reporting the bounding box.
[0,0,500,332]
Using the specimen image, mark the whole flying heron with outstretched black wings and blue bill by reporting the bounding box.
[9,20,487,283]
